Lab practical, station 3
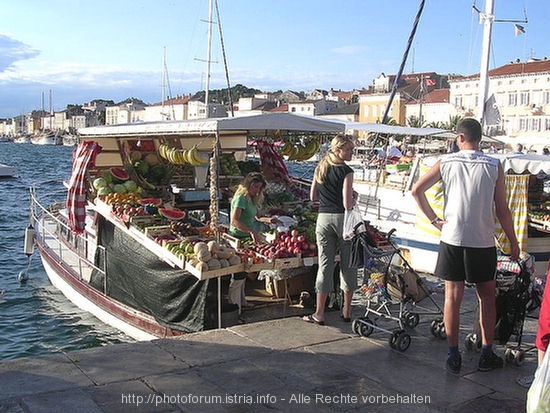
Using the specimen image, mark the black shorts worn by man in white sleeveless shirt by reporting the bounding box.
[435,242,497,284]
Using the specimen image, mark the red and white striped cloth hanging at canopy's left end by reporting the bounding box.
[67,141,101,233]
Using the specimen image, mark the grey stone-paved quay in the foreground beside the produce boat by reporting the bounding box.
[0,289,536,413]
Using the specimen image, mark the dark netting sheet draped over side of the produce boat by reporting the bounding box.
[91,218,217,333]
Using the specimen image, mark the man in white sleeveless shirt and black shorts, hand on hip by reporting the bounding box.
[412,118,520,374]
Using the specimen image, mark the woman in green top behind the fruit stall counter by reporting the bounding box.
[229,172,278,313]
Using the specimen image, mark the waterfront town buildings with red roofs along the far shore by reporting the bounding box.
[0,57,550,150]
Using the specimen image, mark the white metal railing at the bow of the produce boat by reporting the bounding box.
[30,187,107,280]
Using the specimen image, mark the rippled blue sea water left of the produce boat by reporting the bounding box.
[0,143,132,360]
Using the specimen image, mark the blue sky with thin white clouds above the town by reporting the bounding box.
[0,0,550,118]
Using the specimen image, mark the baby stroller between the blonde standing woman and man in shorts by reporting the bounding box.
[351,223,446,352]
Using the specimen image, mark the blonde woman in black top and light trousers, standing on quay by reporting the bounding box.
[303,135,357,325]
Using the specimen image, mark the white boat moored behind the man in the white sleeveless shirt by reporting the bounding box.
[354,150,550,275]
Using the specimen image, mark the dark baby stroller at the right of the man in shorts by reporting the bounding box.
[464,255,540,366]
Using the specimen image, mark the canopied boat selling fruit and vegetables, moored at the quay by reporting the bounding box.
[26,114,343,339]
